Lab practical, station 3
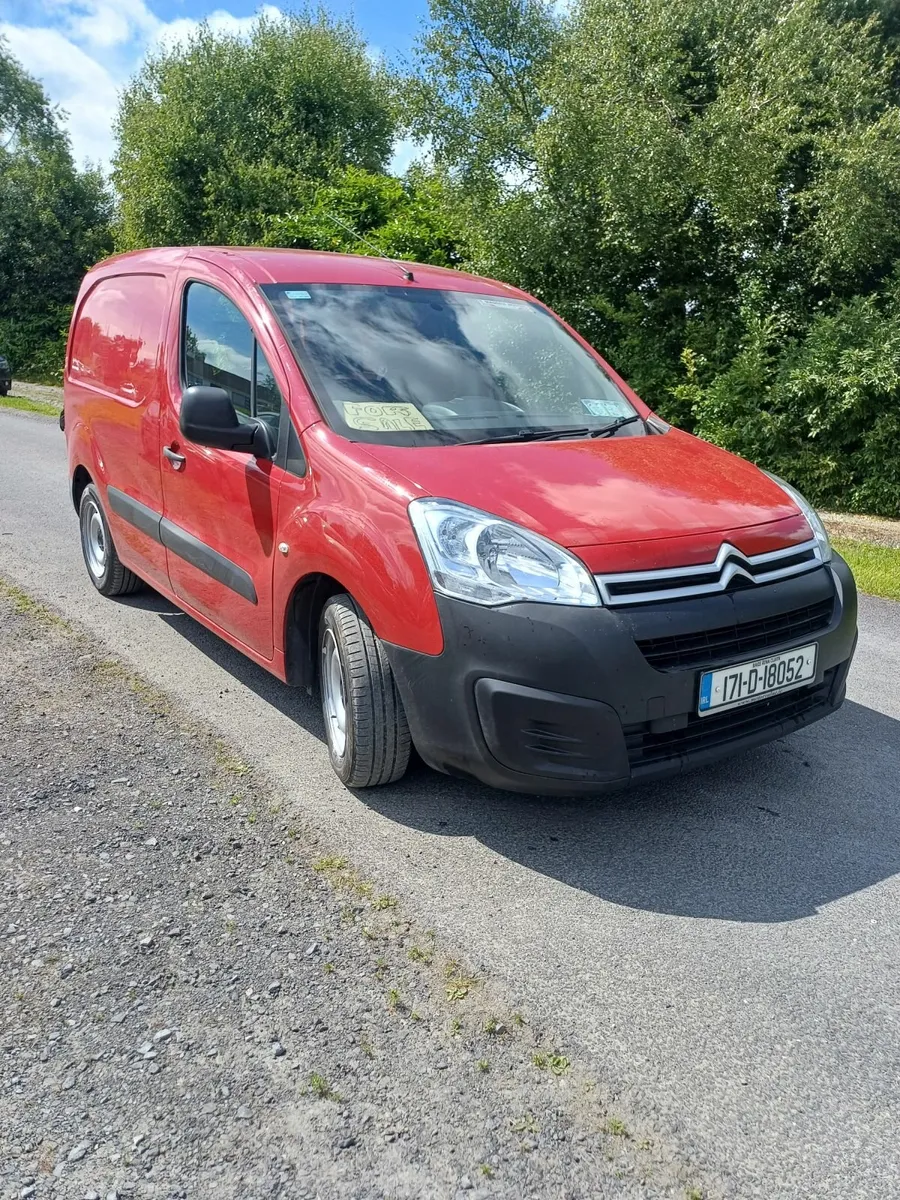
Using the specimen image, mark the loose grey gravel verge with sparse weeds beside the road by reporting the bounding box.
[0,586,716,1200]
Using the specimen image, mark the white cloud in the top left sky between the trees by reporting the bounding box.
[0,0,282,169]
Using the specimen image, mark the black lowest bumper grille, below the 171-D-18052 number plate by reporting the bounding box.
[624,667,836,769]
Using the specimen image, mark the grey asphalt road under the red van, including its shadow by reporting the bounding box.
[0,413,900,1200]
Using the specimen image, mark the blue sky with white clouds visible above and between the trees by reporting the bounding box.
[0,0,427,169]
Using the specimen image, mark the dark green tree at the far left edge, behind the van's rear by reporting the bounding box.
[0,42,112,377]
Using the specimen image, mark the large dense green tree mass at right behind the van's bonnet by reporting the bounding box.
[410,0,900,512]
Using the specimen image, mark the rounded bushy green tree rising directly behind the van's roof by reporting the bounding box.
[113,13,395,248]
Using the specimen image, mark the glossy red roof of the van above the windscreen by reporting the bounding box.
[88,246,524,295]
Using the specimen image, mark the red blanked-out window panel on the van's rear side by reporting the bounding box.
[68,275,169,403]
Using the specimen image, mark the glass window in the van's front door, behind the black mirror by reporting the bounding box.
[182,283,282,430]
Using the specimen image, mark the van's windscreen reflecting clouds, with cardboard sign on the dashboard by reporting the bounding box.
[263,283,647,445]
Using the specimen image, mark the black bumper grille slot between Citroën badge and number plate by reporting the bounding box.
[637,596,834,671]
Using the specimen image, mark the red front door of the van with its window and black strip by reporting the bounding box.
[161,276,283,659]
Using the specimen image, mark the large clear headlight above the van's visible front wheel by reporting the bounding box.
[409,500,600,606]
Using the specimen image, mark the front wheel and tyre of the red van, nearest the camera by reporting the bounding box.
[318,594,410,787]
